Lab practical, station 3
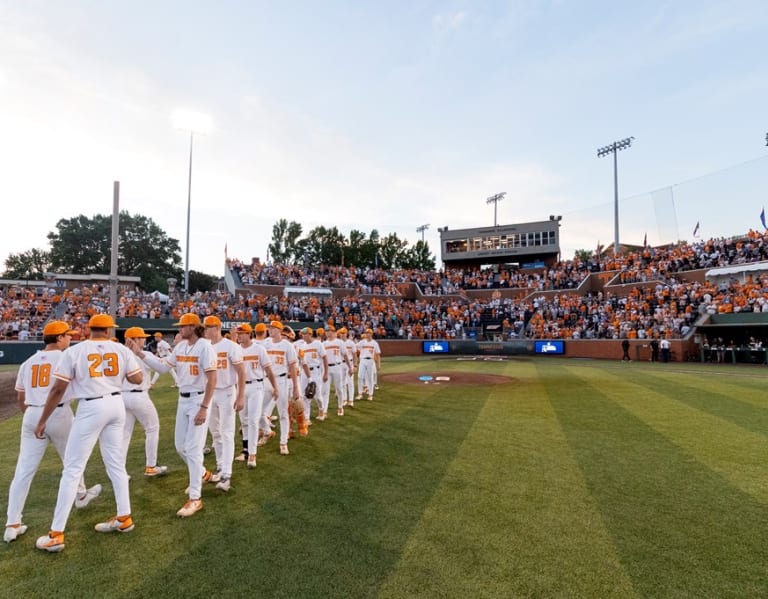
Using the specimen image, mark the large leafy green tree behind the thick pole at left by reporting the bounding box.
[48,211,181,290]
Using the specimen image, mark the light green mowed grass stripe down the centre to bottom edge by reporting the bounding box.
[381,363,634,597]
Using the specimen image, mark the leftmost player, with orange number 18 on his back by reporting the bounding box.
[3,320,101,543]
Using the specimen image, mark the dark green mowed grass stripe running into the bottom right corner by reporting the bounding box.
[544,368,768,597]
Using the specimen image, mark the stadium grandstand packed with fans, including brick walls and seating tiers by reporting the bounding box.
[0,229,768,363]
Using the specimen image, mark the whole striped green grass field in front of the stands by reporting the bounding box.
[0,358,768,598]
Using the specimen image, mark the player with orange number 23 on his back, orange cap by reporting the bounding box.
[35,314,143,552]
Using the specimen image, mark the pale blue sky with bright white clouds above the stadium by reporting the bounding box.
[0,0,768,275]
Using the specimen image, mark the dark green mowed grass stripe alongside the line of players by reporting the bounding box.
[125,372,480,597]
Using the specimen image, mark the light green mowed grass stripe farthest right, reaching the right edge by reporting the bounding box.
[588,377,768,505]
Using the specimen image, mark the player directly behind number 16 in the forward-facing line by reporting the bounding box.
[203,316,245,491]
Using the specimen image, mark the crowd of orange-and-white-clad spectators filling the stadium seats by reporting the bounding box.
[6,231,768,340]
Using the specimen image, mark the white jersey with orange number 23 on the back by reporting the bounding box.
[53,339,141,399]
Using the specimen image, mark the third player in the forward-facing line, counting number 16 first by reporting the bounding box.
[235,323,279,468]
